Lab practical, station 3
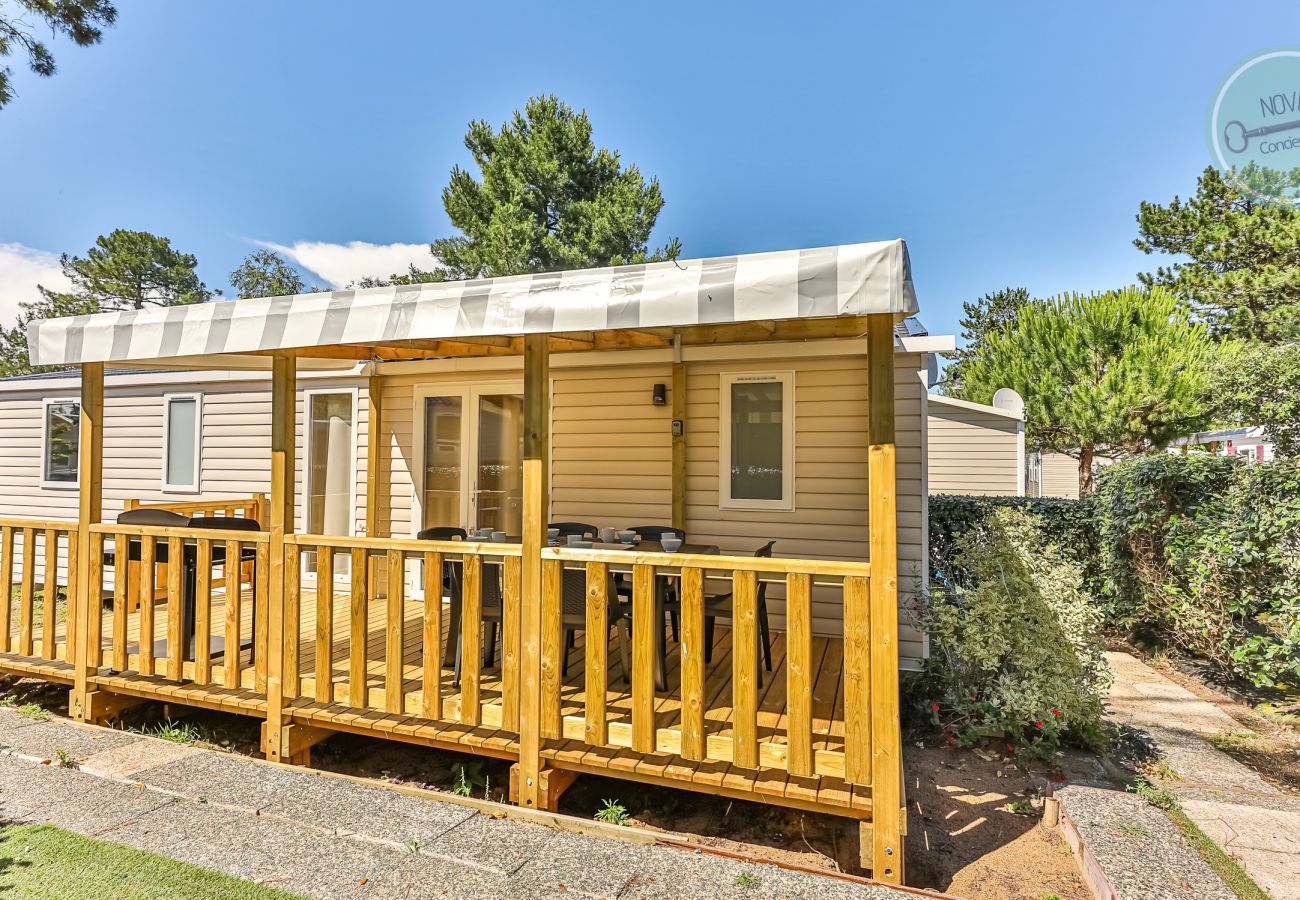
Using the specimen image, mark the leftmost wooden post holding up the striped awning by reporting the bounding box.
[69,363,102,721]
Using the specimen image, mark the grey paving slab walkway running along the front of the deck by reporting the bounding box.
[0,709,915,900]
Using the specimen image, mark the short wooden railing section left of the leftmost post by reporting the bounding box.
[0,519,77,659]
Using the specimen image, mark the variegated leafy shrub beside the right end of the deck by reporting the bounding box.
[923,506,1110,756]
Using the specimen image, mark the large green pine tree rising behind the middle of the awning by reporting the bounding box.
[360,96,681,286]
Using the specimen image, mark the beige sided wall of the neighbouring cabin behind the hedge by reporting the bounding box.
[927,397,1021,496]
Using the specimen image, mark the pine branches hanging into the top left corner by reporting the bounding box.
[0,0,117,108]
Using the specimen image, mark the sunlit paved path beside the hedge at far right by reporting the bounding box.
[1106,653,1300,900]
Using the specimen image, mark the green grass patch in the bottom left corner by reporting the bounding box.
[0,825,296,900]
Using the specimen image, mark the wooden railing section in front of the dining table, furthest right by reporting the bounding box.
[542,548,871,784]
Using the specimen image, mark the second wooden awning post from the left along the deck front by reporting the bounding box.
[259,351,298,762]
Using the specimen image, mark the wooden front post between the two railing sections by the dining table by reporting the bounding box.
[517,334,550,809]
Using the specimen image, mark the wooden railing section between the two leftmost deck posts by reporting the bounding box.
[86,524,270,692]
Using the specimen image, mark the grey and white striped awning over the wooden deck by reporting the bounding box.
[20,241,917,365]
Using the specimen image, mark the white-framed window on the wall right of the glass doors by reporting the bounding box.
[718,372,794,511]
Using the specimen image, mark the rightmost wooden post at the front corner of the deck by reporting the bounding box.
[868,315,904,884]
